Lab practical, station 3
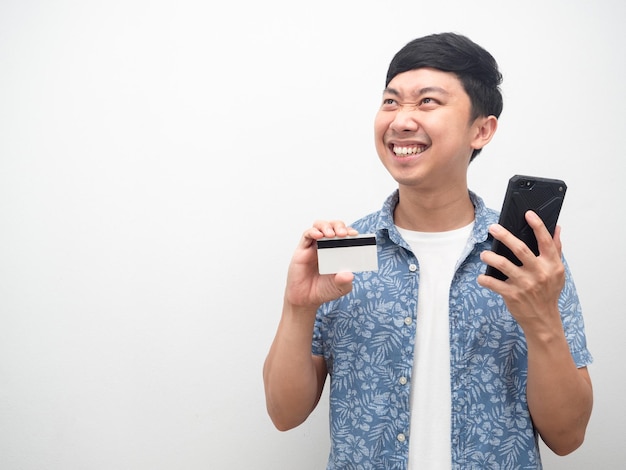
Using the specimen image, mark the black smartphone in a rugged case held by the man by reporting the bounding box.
[485,175,567,281]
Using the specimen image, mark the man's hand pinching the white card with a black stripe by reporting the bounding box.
[285,221,358,309]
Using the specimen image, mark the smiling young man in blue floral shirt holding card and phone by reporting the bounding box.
[264,33,592,470]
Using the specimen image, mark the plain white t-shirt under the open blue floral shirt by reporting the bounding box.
[398,222,474,470]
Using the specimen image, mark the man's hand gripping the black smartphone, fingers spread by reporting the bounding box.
[478,211,565,331]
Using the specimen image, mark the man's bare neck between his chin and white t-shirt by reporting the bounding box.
[393,186,474,232]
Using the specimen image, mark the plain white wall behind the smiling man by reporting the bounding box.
[0,0,626,470]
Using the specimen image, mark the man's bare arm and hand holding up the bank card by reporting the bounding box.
[263,222,356,430]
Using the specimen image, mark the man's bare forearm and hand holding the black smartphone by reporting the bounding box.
[478,211,593,455]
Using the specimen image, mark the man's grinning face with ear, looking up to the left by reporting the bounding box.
[375,68,495,189]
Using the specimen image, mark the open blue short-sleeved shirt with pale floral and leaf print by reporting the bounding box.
[312,191,592,470]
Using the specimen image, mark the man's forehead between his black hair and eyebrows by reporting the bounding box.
[385,68,466,96]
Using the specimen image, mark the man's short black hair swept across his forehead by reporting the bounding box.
[385,33,503,159]
